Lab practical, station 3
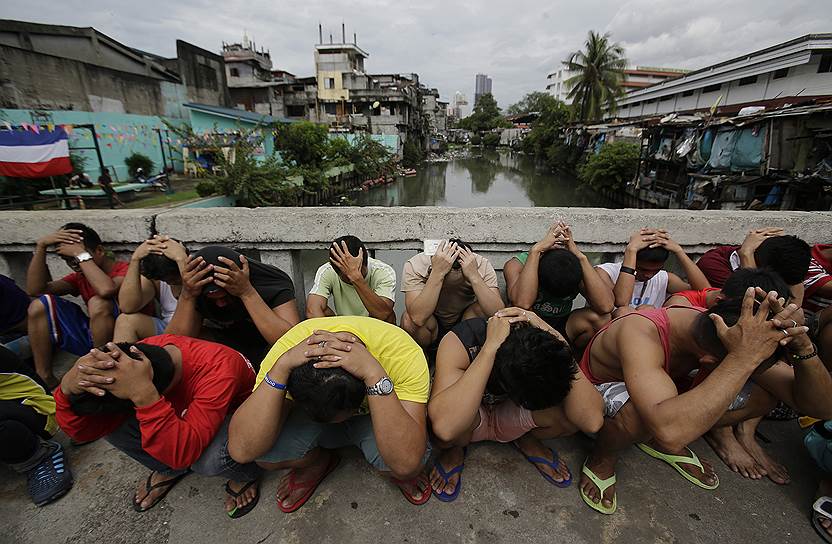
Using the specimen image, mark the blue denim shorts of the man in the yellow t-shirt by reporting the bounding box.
[257,407,431,472]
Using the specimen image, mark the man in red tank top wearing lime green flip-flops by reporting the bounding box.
[580,288,832,514]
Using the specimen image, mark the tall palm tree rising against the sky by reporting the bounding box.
[563,30,627,121]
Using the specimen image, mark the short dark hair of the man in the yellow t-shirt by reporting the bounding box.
[286,361,367,423]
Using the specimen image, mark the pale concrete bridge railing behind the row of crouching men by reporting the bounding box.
[0,207,832,318]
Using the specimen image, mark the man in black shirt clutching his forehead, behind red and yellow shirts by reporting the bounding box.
[165,246,300,363]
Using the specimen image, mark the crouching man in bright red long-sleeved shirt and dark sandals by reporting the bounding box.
[55,334,260,518]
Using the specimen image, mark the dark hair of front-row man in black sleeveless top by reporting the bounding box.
[489,322,578,410]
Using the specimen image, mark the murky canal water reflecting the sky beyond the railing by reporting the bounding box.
[350,150,608,208]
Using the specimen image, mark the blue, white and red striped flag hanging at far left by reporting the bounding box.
[0,126,72,178]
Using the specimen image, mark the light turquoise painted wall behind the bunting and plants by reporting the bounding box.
[0,109,188,181]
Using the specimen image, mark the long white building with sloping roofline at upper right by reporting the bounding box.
[610,33,832,118]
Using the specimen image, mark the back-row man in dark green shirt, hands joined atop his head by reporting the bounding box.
[503,221,614,345]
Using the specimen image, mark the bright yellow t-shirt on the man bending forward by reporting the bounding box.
[254,315,430,404]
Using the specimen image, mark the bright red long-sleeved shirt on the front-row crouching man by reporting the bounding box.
[55,334,254,470]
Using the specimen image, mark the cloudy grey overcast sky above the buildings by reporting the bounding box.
[0,0,832,113]
